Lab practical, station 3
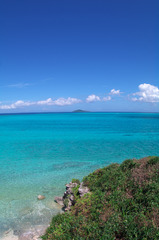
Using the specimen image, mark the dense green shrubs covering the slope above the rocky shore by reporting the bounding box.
[42,157,159,240]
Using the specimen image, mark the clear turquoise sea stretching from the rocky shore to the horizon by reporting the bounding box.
[0,113,159,234]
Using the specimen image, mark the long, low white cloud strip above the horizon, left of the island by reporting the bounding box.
[0,97,81,109]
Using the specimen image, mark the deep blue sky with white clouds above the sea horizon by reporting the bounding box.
[0,0,159,113]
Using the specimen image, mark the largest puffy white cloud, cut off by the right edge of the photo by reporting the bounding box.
[132,83,159,103]
